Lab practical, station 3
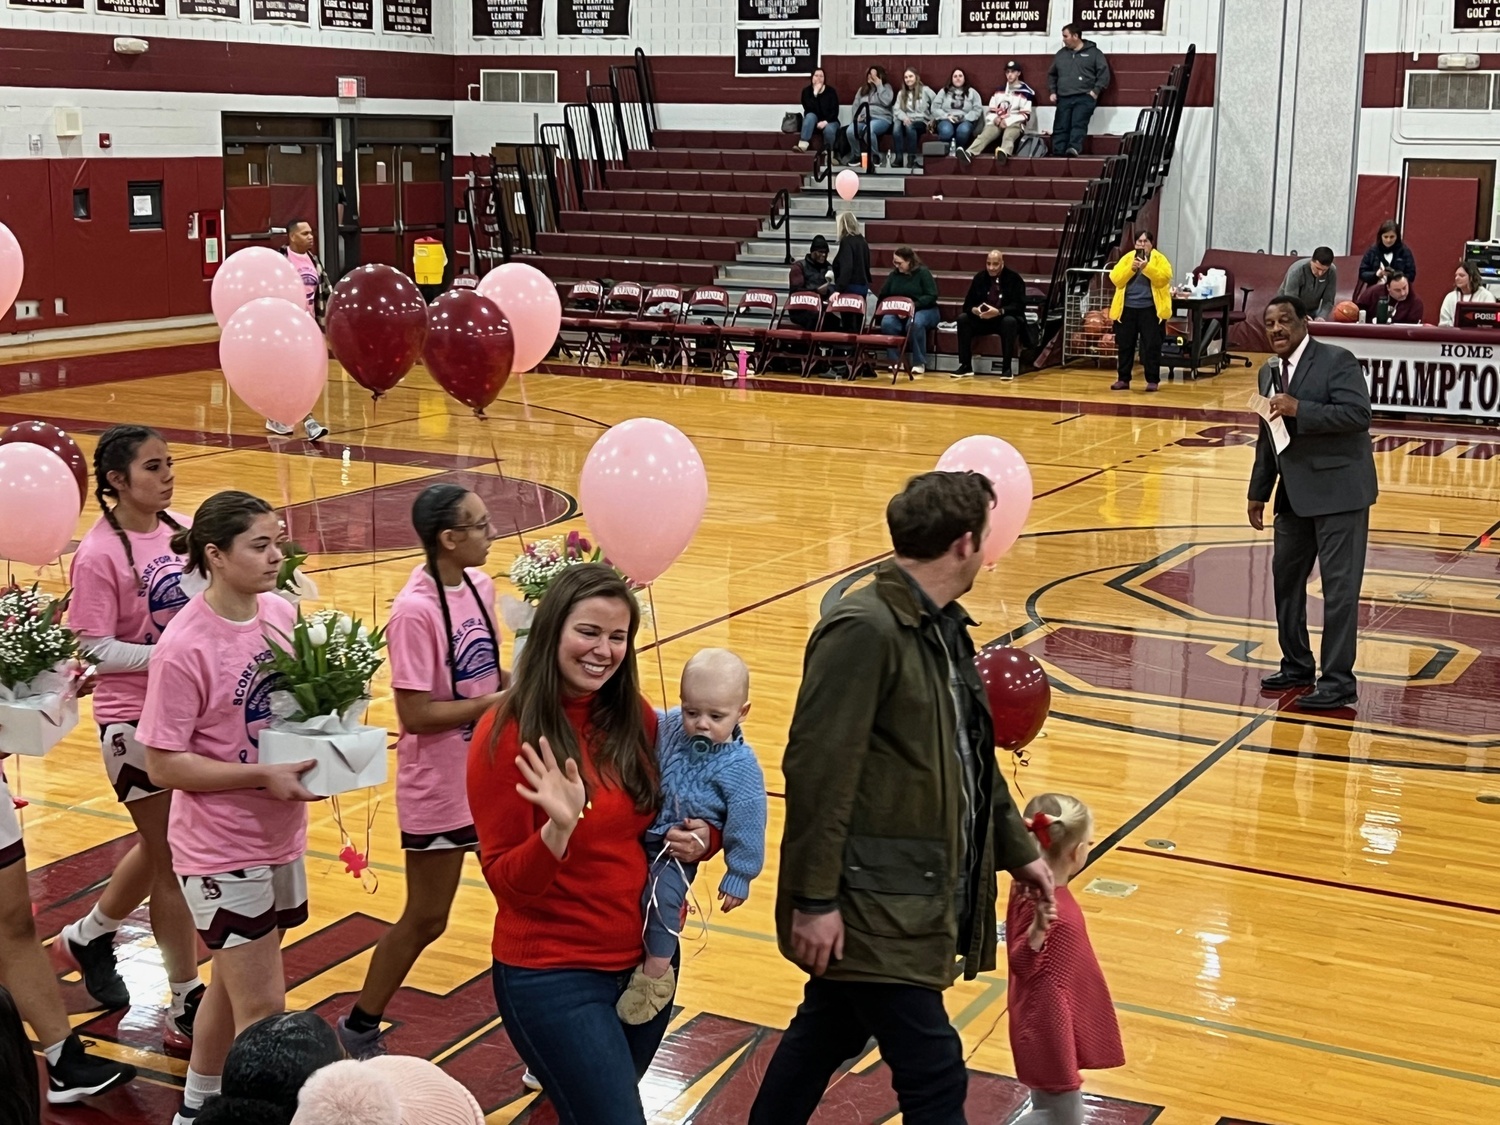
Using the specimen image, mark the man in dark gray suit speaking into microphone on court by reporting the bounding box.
[1248,297,1377,711]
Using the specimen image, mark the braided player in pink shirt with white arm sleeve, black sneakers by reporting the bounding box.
[53,426,203,1050]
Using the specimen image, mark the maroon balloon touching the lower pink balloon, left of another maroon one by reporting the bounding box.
[327,266,428,399]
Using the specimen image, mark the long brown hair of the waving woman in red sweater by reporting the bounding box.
[489,563,662,813]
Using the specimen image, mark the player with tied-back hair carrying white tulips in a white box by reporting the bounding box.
[137,492,318,1125]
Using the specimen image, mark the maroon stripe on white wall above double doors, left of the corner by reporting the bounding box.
[0,27,450,101]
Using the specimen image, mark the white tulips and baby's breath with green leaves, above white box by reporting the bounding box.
[261,609,386,723]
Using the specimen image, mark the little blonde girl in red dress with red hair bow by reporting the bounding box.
[1005,794,1125,1125]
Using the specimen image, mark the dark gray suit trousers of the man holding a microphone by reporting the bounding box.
[1271,488,1370,695]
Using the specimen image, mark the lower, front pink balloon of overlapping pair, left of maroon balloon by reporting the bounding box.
[219,297,329,426]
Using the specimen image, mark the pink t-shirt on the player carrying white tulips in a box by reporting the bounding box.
[137,594,308,875]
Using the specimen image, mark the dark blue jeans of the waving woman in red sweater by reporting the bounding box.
[492,957,680,1125]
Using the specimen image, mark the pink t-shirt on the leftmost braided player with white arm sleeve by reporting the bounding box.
[68,512,192,726]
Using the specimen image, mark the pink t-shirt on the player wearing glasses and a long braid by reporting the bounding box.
[386,566,500,836]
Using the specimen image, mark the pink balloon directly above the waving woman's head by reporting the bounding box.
[578,419,708,585]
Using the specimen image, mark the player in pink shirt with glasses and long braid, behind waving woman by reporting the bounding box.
[339,485,503,1059]
